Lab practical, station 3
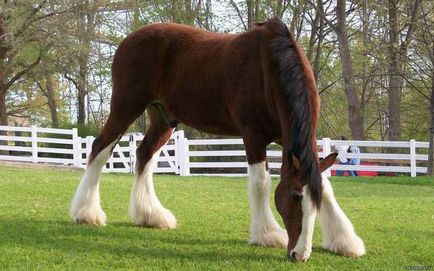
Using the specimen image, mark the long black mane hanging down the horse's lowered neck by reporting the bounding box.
[265,18,322,209]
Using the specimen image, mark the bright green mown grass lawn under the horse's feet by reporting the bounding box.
[0,168,434,270]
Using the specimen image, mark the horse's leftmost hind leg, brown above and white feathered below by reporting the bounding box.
[70,112,134,225]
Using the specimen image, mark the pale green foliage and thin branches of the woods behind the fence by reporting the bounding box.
[0,0,434,144]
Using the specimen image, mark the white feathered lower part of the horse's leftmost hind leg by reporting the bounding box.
[70,140,117,226]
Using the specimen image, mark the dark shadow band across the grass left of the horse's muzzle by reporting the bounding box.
[0,217,285,262]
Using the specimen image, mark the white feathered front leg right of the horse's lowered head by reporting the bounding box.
[320,174,366,257]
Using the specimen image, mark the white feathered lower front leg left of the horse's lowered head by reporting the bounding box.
[248,161,288,247]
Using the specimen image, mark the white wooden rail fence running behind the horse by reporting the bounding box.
[0,126,429,177]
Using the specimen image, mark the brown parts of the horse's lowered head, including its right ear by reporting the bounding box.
[275,153,337,256]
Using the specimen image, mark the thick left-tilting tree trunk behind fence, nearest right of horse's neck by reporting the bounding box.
[336,0,365,140]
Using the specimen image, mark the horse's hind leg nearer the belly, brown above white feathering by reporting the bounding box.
[129,106,176,229]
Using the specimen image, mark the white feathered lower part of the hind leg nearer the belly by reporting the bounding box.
[129,151,176,229]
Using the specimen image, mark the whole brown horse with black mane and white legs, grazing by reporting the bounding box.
[71,18,364,260]
